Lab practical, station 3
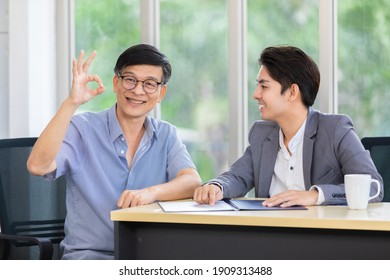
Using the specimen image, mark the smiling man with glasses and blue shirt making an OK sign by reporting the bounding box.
[27,44,201,259]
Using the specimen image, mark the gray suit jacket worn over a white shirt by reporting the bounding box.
[212,108,383,204]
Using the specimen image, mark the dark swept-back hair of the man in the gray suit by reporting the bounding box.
[259,46,320,107]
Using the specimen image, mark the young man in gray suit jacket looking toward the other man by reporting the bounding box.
[194,46,383,207]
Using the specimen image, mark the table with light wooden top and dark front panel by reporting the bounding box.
[111,200,390,260]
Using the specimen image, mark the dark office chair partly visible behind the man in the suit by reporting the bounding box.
[361,136,390,202]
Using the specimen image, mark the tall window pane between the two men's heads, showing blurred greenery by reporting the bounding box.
[160,0,229,180]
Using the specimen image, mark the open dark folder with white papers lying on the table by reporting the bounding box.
[158,199,307,212]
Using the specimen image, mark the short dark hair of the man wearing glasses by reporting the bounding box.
[114,44,172,84]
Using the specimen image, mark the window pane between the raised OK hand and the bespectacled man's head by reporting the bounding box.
[74,0,140,111]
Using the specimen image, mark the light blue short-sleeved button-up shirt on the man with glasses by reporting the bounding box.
[46,105,195,259]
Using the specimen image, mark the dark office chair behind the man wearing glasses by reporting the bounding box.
[0,138,66,259]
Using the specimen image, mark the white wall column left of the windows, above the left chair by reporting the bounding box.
[7,0,57,137]
